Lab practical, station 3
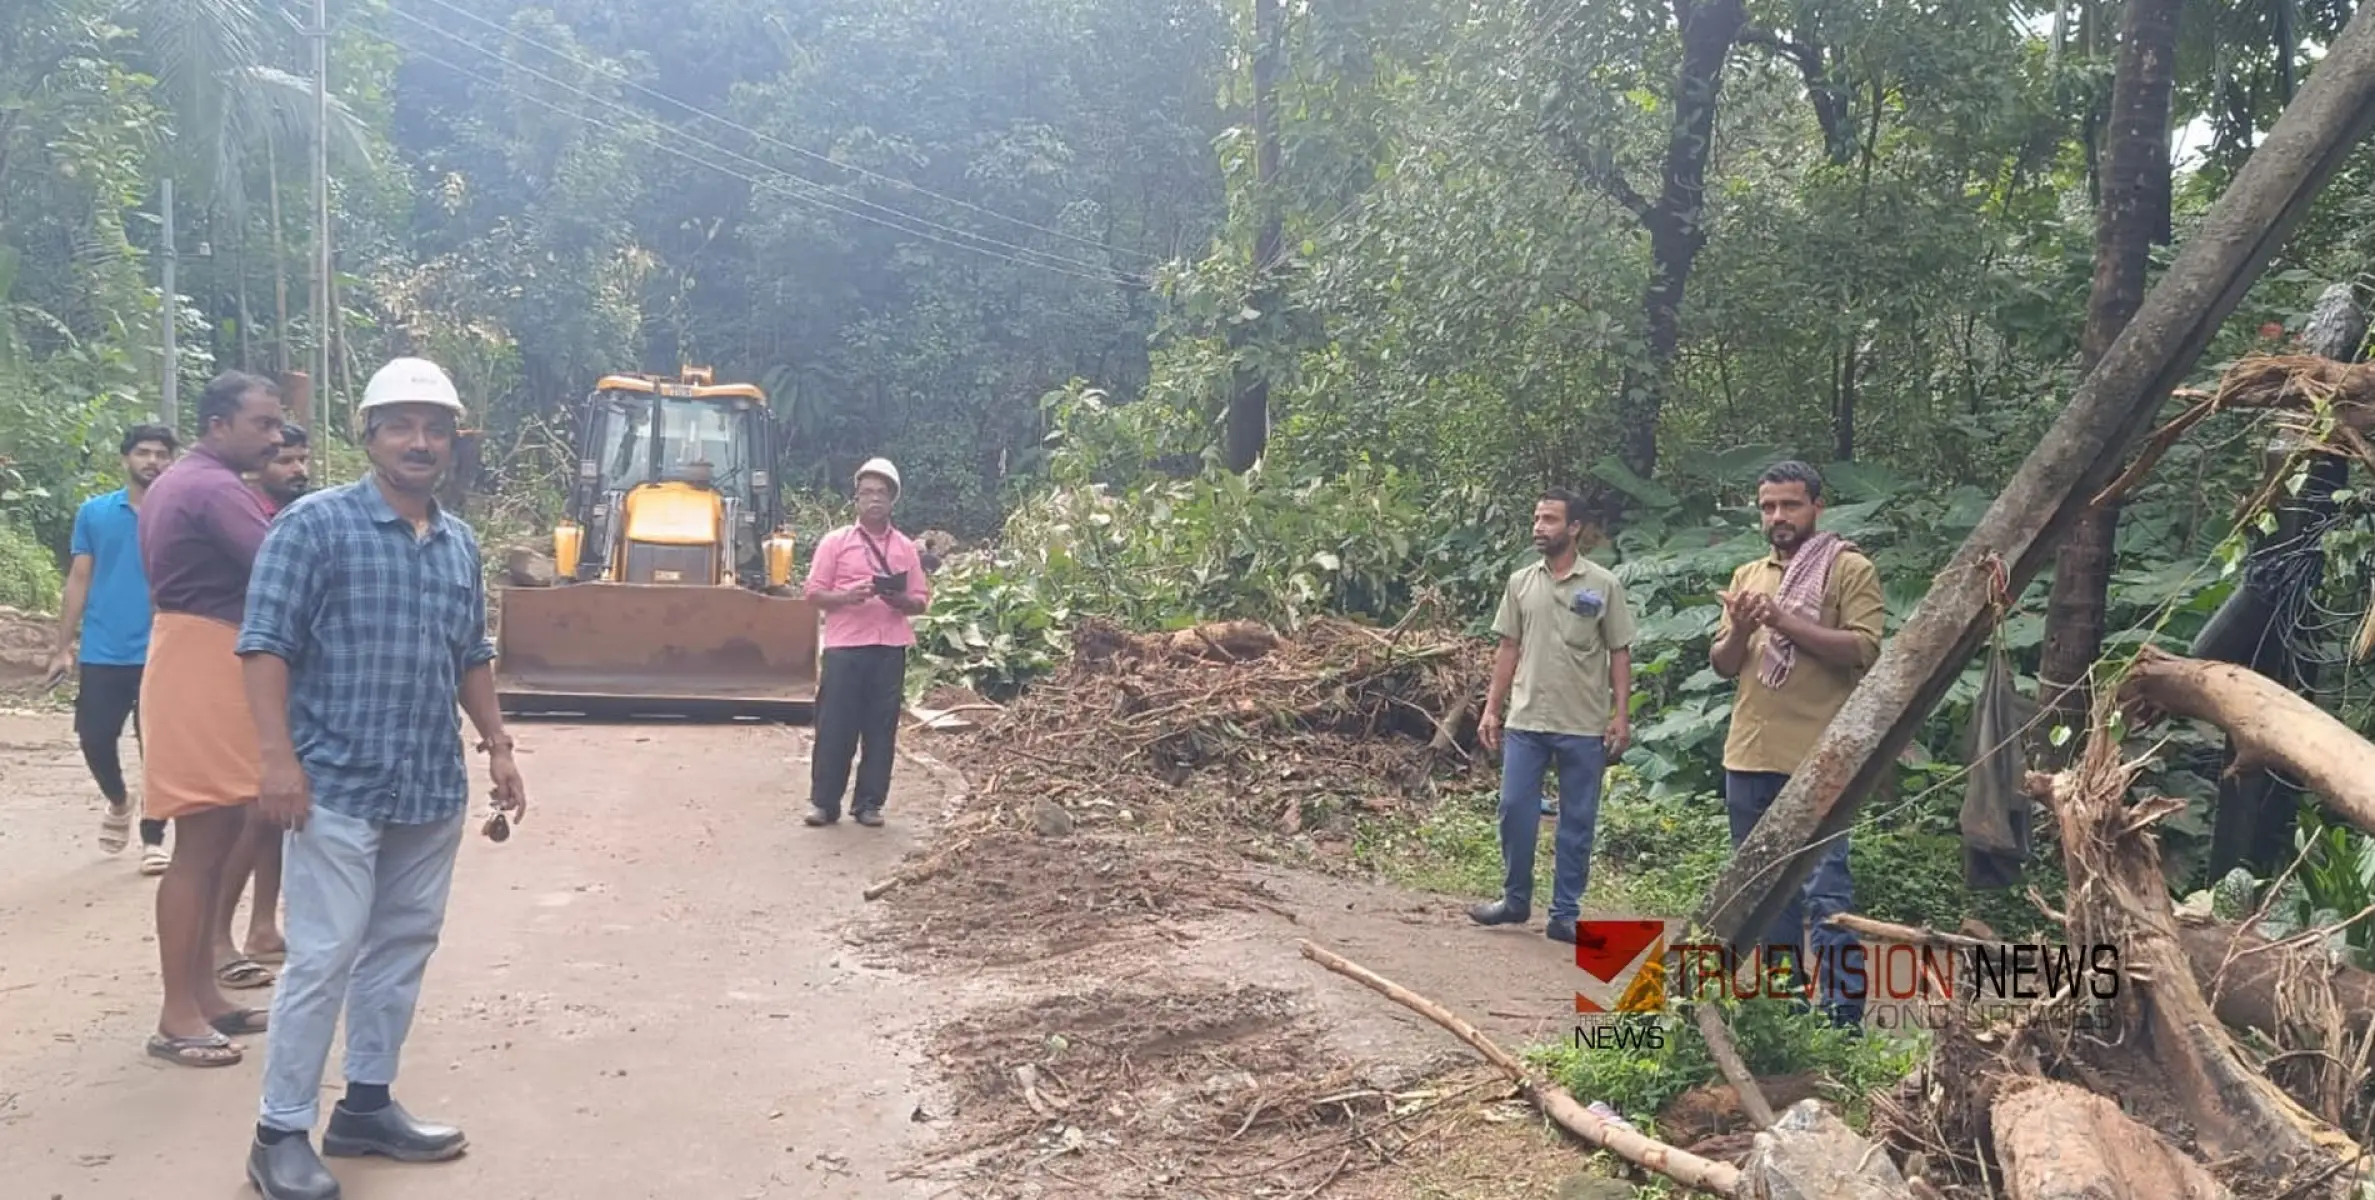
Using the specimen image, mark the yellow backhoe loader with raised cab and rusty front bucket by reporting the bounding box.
[494,368,817,720]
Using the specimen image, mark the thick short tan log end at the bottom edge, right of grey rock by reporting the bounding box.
[1995,1079,2228,1200]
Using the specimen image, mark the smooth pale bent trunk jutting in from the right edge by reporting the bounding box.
[2121,646,2375,834]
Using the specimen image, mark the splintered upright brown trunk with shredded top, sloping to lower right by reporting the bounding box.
[2031,722,2361,1198]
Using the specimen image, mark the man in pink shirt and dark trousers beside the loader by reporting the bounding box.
[805,459,931,827]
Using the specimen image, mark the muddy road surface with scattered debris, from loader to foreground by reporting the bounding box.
[0,698,1582,1200]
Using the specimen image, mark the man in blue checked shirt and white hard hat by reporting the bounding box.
[238,359,527,1200]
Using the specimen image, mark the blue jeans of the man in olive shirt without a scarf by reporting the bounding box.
[1501,730,1608,922]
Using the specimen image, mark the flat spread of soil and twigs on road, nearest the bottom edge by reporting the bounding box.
[905,979,1506,1200]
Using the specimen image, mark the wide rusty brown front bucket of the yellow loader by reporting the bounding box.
[494,582,817,720]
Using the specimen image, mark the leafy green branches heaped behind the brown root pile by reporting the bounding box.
[917,387,1532,694]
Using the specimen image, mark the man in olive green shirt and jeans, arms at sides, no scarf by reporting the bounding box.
[1468,487,1634,943]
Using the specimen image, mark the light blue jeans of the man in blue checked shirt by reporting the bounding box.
[259,806,468,1131]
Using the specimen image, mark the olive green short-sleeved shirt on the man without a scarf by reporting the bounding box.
[1492,556,1634,737]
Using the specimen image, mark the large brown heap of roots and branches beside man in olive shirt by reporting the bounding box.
[967,620,1492,846]
